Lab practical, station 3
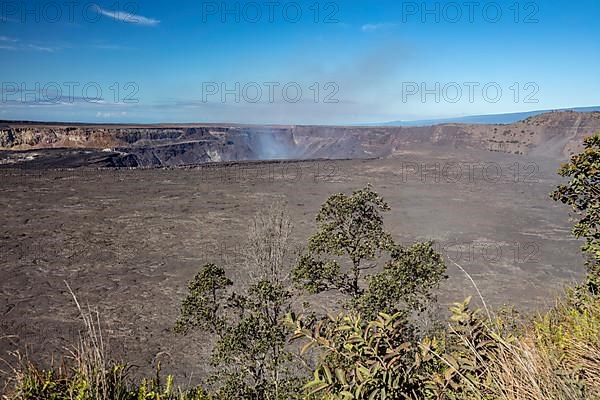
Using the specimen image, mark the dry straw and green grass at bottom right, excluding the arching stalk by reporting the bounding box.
[446,291,600,400]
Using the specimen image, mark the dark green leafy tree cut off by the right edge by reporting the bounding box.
[551,133,600,294]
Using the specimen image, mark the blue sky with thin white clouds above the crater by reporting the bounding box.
[0,0,600,124]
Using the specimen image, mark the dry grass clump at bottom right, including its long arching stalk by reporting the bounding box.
[438,260,600,400]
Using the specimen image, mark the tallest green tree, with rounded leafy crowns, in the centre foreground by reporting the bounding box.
[293,185,446,319]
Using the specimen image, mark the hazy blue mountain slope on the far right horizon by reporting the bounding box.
[376,106,600,126]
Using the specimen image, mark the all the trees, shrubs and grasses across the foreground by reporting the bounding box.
[4,134,600,400]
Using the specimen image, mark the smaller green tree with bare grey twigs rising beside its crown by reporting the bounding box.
[175,205,298,400]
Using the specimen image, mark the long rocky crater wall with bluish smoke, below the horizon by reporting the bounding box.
[0,111,600,168]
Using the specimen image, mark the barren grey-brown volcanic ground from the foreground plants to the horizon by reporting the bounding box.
[0,113,600,383]
